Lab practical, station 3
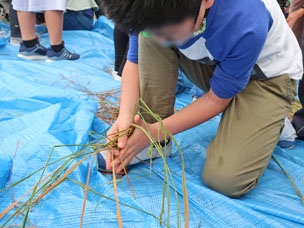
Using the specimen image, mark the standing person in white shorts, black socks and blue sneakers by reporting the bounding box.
[12,0,80,62]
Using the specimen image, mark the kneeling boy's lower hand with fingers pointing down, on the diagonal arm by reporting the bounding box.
[107,116,155,173]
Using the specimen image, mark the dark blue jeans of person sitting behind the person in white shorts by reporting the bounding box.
[63,9,94,30]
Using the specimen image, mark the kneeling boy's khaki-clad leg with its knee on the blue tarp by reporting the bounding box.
[203,75,296,197]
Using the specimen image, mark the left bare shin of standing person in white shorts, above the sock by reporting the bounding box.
[18,11,36,41]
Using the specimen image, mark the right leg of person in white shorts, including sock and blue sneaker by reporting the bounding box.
[44,10,80,62]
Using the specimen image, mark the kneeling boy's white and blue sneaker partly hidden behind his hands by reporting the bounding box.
[97,139,172,174]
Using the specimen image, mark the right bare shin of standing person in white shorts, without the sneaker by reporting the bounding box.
[44,10,63,46]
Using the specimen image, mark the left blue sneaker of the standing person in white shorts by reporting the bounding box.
[18,43,47,60]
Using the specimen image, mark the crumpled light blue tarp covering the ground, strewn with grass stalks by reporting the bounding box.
[0,18,304,228]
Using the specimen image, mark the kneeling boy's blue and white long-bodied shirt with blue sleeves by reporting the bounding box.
[128,0,302,98]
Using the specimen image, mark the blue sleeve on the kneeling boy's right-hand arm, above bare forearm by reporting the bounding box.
[210,29,268,99]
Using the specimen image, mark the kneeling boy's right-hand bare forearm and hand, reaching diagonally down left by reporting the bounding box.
[108,90,232,173]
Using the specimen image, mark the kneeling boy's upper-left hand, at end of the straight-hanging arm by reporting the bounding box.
[106,117,133,170]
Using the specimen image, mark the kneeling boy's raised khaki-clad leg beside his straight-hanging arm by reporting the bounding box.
[139,36,178,123]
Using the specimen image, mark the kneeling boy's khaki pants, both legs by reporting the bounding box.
[139,34,296,197]
